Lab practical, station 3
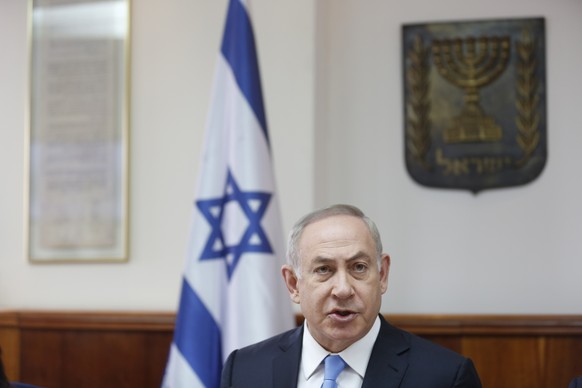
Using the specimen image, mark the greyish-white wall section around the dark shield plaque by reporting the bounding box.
[315,0,582,313]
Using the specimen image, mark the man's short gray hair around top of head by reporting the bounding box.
[287,204,382,277]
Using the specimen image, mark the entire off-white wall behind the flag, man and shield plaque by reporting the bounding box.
[0,0,582,313]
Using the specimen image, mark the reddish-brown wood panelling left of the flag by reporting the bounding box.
[0,312,174,388]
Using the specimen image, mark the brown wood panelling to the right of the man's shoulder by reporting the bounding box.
[387,315,582,388]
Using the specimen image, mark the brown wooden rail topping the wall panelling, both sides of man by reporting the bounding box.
[0,310,582,335]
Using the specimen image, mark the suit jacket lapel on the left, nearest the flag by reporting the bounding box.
[273,325,303,388]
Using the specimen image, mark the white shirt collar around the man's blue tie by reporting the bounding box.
[301,317,380,380]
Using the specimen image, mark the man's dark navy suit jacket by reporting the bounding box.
[221,316,481,388]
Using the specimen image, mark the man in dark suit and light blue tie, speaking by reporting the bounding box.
[222,205,481,388]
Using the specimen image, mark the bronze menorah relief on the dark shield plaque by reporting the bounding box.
[432,37,510,143]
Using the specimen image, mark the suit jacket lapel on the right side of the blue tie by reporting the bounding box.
[362,316,410,388]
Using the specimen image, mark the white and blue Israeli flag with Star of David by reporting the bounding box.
[162,0,294,388]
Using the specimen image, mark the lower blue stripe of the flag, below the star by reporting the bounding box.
[174,279,222,387]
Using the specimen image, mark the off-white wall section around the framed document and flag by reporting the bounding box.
[0,0,314,310]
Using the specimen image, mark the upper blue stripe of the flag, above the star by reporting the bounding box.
[221,0,269,144]
